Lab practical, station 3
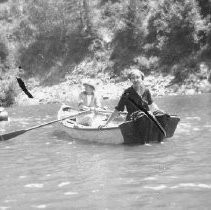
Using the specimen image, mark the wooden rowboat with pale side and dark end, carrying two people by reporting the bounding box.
[58,106,180,144]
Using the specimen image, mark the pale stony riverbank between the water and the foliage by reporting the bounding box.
[15,74,211,105]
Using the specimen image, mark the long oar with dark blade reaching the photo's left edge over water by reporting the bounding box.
[0,111,91,141]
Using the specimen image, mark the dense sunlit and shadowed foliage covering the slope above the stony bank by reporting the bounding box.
[0,0,211,105]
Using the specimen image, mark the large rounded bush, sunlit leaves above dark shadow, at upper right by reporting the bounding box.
[148,0,205,69]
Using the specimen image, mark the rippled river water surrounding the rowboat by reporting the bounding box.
[0,94,211,210]
